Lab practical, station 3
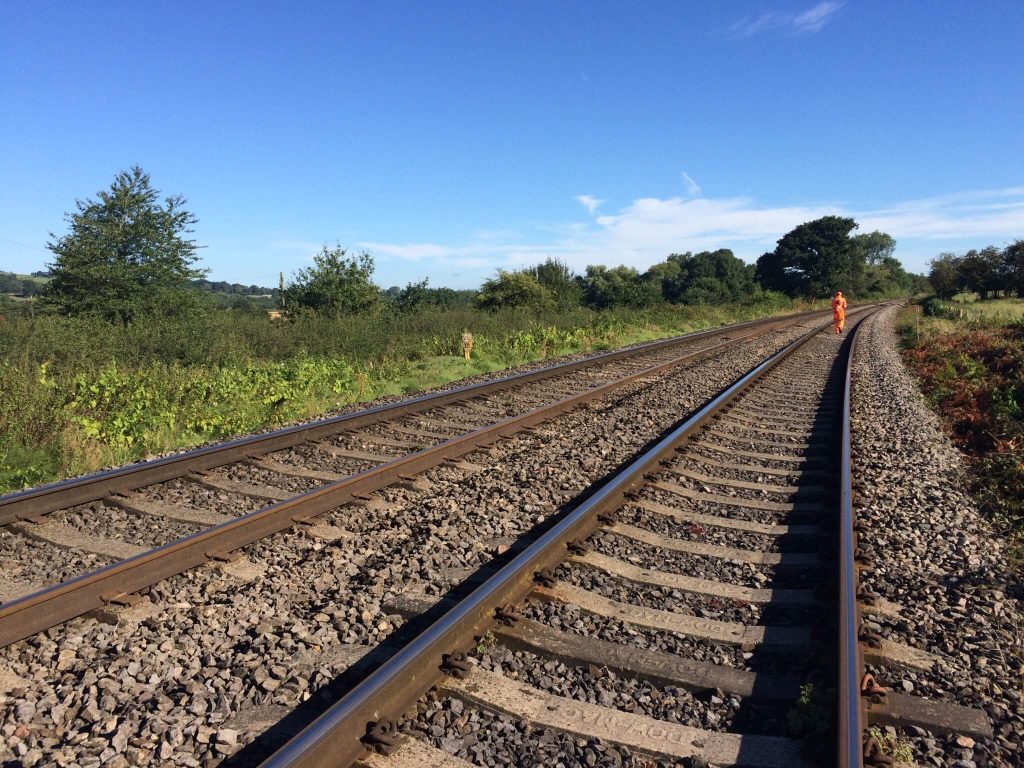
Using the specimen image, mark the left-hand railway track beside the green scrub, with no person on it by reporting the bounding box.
[0,313,820,647]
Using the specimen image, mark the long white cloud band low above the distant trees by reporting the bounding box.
[357,186,1024,278]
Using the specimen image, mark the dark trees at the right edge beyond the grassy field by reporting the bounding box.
[928,240,1024,301]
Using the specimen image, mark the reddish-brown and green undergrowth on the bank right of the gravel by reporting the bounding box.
[900,298,1024,566]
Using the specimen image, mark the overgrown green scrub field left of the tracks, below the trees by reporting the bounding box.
[0,294,808,493]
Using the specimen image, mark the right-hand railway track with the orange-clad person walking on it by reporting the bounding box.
[251,309,991,768]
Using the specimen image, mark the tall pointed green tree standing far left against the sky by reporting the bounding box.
[43,166,206,323]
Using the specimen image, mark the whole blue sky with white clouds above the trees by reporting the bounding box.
[0,0,1024,287]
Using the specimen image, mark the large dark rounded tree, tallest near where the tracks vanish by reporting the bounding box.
[757,216,864,296]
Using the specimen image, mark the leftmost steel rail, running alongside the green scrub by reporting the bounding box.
[0,311,820,525]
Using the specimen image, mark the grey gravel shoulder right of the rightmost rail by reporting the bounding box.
[852,307,1024,768]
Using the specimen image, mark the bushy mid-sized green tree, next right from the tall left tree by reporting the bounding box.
[283,246,381,317]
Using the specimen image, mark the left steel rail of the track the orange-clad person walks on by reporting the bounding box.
[261,307,872,768]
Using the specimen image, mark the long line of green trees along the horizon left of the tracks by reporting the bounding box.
[19,166,924,323]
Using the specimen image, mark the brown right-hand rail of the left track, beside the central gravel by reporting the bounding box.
[0,319,798,647]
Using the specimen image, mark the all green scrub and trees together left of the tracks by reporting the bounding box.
[0,167,912,492]
